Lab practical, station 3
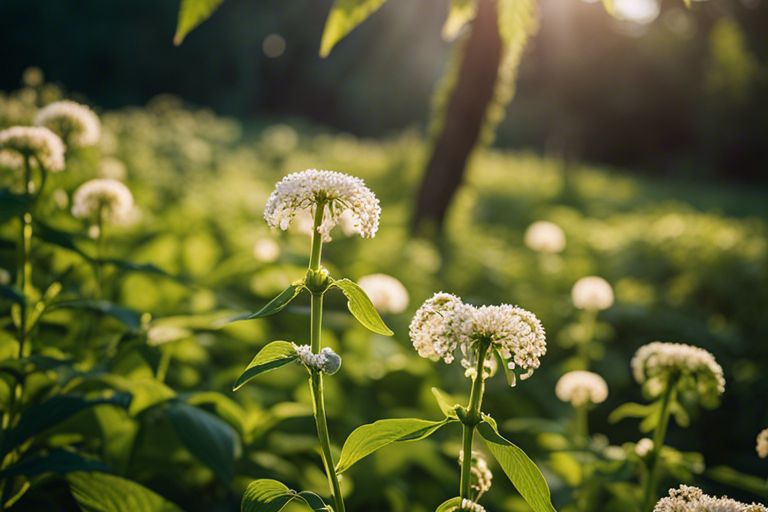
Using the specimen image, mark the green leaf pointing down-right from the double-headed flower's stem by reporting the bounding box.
[477,422,557,512]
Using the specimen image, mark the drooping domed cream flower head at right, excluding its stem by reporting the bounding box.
[631,341,725,407]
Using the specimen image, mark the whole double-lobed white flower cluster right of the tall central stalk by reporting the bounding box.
[410,292,547,380]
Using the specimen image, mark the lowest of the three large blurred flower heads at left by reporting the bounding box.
[72,179,133,224]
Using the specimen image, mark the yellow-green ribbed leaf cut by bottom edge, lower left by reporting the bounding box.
[67,471,182,512]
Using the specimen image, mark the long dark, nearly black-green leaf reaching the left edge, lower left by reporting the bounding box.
[0,393,131,455]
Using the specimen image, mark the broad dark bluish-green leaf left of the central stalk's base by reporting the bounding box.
[166,401,240,484]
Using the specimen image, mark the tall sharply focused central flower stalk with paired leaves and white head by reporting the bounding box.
[235,169,392,512]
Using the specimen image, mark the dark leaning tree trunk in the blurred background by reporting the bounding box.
[413,0,502,232]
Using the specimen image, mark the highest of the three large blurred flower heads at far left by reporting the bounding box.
[35,100,101,147]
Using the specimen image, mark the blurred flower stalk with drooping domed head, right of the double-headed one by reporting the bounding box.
[628,342,725,512]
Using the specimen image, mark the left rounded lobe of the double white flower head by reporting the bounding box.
[409,292,468,363]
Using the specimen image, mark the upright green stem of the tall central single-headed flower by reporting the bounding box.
[309,201,345,512]
